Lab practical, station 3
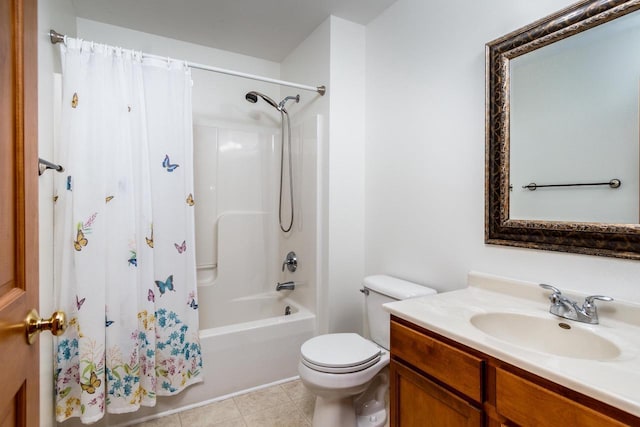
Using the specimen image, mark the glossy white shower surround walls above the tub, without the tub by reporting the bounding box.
[194,117,319,314]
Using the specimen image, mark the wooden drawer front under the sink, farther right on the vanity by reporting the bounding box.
[496,368,627,427]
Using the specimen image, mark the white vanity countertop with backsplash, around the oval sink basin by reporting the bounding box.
[384,272,640,416]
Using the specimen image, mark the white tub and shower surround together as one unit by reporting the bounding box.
[189,117,319,418]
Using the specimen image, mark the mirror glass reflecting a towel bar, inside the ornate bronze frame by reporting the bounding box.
[509,11,640,224]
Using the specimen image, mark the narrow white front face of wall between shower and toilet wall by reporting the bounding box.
[327,17,365,332]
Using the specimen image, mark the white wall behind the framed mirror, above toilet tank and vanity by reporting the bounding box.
[365,0,640,301]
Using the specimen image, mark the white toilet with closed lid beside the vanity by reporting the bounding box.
[298,275,436,427]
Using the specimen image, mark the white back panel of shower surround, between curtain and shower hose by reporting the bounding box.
[194,124,279,290]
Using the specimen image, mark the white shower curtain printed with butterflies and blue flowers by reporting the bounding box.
[54,39,202,423]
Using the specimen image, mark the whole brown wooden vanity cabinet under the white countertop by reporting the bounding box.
[390,316,640,427]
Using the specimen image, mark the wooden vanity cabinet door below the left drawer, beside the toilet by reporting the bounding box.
[390,360,482,427]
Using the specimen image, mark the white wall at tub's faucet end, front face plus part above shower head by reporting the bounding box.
[282,16,365,333]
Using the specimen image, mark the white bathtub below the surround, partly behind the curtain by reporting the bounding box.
[99,292,315,426]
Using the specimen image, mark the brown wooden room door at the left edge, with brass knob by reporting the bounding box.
[0,0,40,427]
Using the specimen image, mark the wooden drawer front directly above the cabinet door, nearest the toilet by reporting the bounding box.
[391,321,484,403]
